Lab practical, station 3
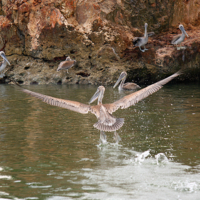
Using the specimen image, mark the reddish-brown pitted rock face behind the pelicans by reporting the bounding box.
[0,0,200,85]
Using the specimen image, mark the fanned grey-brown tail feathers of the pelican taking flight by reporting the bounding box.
[93,118,124,132]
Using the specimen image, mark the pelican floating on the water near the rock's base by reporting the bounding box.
[113,72,140,91]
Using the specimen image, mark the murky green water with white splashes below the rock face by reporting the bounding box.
[0,84,200,200]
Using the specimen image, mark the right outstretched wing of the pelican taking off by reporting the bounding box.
[105,70,181,113]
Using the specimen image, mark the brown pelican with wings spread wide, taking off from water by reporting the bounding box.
[15,71,181,143]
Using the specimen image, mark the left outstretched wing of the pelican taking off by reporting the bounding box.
[22,88,90,114]
